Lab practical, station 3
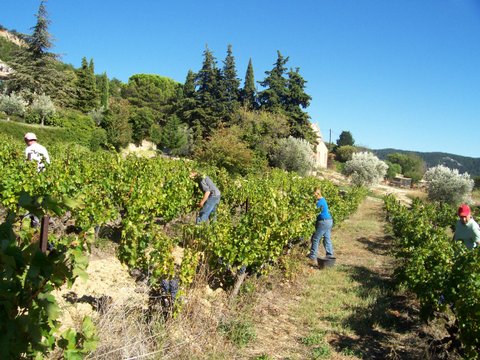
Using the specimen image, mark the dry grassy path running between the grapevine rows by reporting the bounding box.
[242,197,424,359]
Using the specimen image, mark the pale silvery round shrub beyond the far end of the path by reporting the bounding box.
[344,152,388,186]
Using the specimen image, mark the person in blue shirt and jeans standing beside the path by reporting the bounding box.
[308,189,335,263]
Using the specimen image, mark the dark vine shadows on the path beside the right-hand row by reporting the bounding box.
[331,236,425,359]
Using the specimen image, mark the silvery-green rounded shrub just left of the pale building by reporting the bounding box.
[270,136,315,175]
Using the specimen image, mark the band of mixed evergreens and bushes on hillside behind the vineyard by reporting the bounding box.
[0,0,317,174]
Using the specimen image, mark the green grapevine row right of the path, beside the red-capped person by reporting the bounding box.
[385,196,480,359]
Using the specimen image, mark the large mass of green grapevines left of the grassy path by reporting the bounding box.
[0,137,365,358]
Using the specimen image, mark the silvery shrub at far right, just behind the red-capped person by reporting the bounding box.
[424,165,474,205]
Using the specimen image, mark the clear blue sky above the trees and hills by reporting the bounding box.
[0,0,480,157]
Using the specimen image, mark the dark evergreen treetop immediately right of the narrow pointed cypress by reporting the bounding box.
[258,51,288,113]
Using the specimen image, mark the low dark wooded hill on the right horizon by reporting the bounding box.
[372,149,480,176]
